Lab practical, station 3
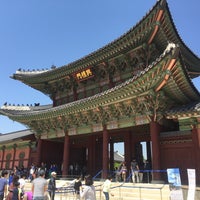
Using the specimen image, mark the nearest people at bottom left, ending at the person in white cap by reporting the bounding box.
[0,169,56,200]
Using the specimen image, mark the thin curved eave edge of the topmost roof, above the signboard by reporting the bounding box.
[11,0,200,85]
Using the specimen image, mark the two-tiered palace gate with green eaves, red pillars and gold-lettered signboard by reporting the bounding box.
[0,0,200,182]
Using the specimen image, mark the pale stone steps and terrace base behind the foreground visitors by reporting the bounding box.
[25,180,172,200]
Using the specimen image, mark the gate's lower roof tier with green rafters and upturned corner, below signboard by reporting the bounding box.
[0,46,200,124]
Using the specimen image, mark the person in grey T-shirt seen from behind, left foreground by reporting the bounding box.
[32,170,47,200]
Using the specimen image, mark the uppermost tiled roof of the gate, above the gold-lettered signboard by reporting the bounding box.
[12,0,200,85]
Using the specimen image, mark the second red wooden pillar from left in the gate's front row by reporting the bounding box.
[62,132,70,176]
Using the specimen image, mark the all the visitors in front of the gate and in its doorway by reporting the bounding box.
[0,158,151,200]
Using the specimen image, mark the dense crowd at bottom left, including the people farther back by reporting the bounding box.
[0,162,58,200]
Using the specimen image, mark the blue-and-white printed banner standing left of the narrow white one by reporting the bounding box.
[167,168,183,200]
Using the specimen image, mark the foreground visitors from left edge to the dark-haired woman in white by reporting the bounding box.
[0,169,96,200]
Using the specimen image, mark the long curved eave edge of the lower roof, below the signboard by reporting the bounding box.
[0,47,200,122]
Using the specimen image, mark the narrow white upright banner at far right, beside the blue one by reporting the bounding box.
[187,169,196,200]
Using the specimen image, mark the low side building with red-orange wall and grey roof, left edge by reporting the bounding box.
[0,130,36,170]
